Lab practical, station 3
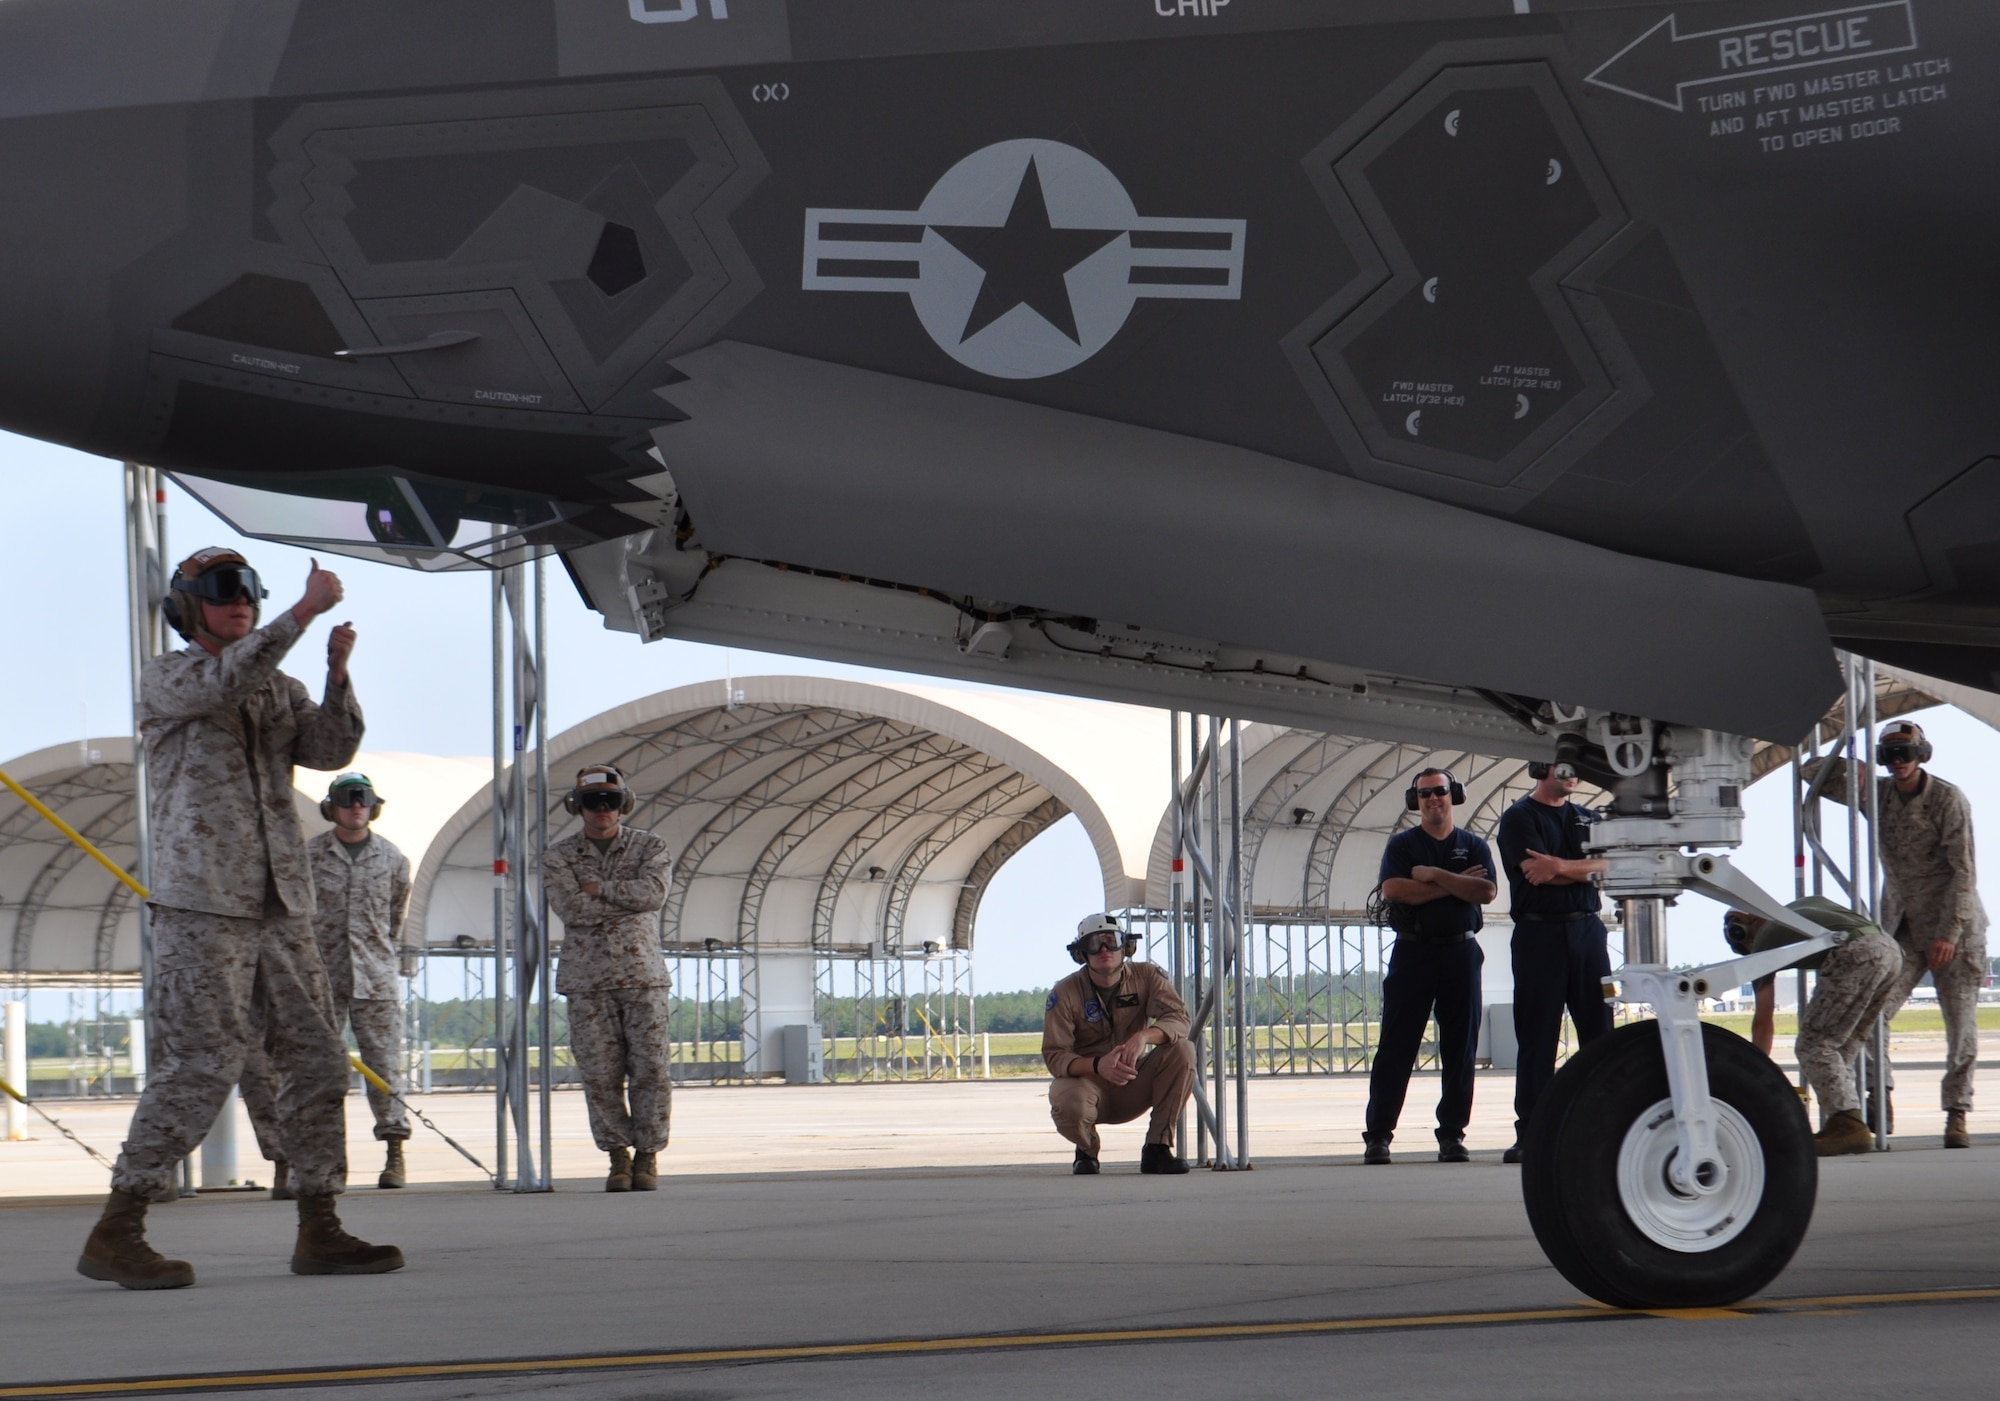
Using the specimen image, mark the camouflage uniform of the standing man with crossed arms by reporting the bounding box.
[542,827,674,1153]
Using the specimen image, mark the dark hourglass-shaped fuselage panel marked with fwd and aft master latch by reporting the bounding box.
[1312,64,1626,484]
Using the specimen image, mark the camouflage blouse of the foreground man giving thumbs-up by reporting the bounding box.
[138,608,362,919]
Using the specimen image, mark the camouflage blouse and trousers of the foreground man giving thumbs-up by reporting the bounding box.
[112,608,362,1201]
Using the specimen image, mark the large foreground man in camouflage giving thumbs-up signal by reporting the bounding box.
[76,548,402,1289]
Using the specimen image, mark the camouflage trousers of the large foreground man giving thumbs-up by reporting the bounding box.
[112,893,348,1201]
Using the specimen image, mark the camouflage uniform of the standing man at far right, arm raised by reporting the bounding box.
[1826,759,1986,1111]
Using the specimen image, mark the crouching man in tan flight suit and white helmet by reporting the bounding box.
[1042,915,1194,1177]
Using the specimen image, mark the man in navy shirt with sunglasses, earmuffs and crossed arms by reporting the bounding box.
[1362,769,1498,1163]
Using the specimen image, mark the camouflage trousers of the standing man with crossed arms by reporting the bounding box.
[570,987,674,1153]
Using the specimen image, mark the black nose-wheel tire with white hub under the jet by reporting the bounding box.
[1520,1021,1820,1309]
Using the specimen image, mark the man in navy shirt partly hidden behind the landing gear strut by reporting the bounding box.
[1496,765,1612,1163]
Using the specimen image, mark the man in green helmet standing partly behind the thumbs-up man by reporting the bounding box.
[244,773,416,1201]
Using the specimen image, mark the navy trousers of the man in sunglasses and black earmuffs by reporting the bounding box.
[1366,939,1486,1141]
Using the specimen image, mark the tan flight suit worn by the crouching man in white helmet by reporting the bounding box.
[1042,963,1194,1157]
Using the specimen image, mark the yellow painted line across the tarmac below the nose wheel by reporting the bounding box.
[11,1289,2000,1401]
